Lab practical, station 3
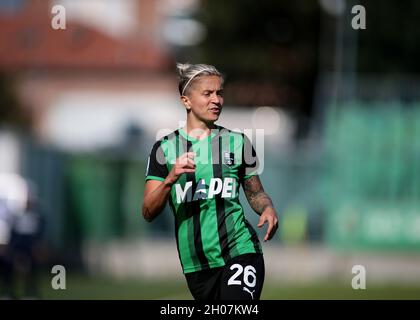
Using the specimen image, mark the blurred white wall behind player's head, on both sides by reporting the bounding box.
[43,91,294,151]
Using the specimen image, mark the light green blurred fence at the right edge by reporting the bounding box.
[323,102,420,249]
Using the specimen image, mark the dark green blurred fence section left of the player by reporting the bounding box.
[67,155,148,241]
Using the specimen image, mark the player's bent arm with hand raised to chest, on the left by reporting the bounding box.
[142,152,195,222]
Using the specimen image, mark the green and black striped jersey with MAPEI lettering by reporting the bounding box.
[146,126,262,273]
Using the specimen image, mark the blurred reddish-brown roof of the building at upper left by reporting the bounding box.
[0,5,169,71]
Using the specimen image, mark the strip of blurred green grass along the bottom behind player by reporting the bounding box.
[36,275,420,300]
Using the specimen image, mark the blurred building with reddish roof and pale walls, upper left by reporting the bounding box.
[0,1,173,150]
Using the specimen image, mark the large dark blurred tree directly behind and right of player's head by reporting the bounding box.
[198,0,320,137]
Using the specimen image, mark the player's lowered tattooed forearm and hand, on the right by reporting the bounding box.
[243,175,278,241]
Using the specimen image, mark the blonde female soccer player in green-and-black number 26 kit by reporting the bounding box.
[142,64,278,300]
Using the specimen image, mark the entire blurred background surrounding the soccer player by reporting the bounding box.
[0,0,420,299]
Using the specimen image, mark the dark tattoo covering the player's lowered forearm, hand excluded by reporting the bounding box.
[244,176,274,214]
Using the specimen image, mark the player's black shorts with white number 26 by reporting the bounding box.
[185,253,265,300]
